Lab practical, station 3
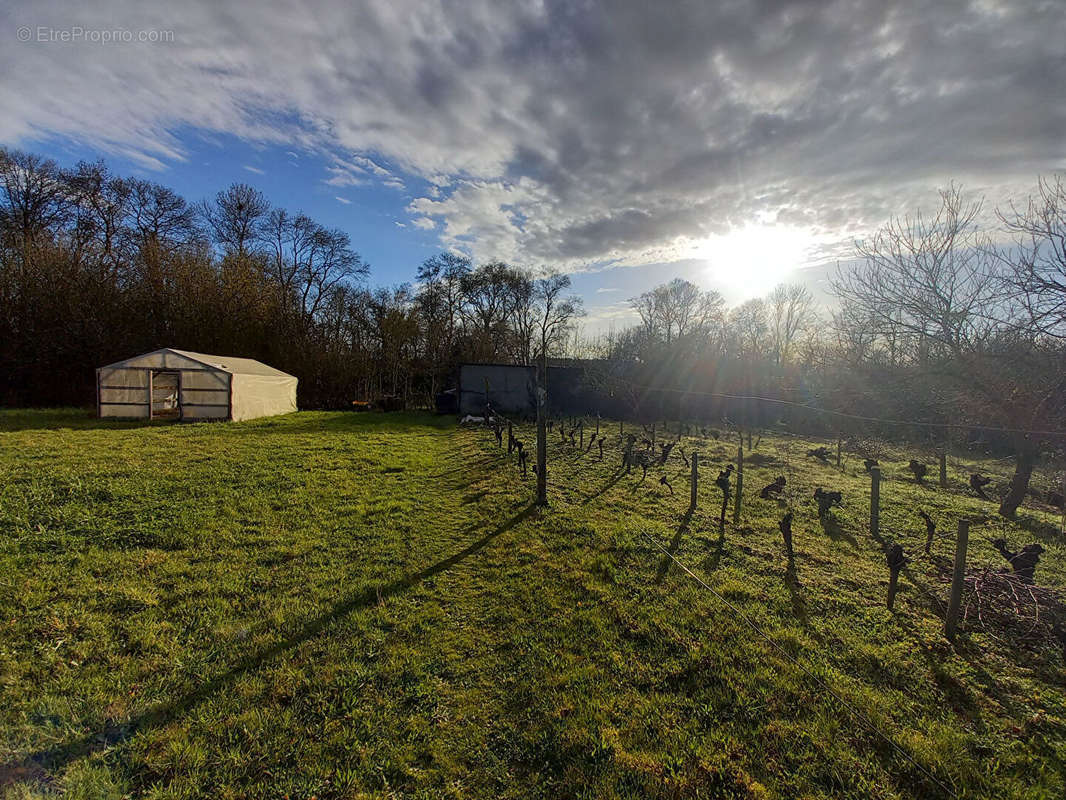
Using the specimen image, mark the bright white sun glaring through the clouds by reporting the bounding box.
[693,224,817,300]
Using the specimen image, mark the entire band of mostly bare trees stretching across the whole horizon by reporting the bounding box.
[0,149,1066,512]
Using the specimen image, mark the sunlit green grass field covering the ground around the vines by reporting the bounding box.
[0,412,1066,799]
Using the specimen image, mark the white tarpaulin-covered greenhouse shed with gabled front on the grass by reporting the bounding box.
[96,348,296,420]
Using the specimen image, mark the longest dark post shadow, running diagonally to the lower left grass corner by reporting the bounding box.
[0,503,536,775]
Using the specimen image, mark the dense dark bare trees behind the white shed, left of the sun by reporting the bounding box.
[0,149,580,407]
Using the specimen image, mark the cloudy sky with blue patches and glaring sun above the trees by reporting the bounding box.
[0,0,1066,331]
